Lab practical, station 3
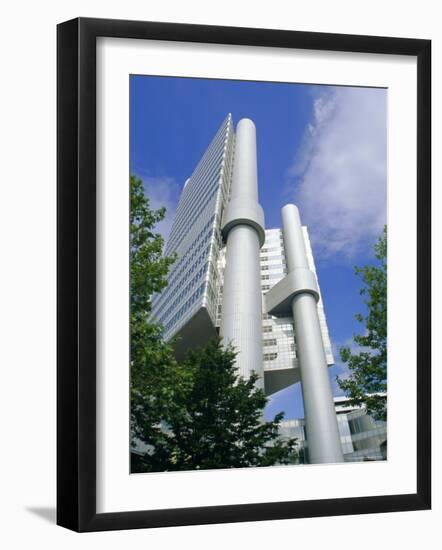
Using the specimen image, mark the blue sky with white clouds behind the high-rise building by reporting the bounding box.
[130,75,387,418]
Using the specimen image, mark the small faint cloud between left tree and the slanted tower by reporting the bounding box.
[140,176,180,242]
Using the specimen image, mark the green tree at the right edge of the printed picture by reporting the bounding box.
[336,227,387,420]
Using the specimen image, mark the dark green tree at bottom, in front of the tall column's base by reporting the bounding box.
[136,340,296,470]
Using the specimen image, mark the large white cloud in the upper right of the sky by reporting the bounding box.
[289,88,387,258]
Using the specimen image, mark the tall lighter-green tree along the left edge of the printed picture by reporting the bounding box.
[130,176,186,471]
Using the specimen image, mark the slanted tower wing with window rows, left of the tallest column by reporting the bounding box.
[152,115,235,356]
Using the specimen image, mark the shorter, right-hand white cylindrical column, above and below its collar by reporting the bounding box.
[282,204,344,464]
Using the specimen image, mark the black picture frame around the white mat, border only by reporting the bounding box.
[57,18,431,532]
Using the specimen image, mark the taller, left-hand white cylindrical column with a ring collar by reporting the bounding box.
[221,119,264,388]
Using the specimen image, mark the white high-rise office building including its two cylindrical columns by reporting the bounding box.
[152,115,343,463]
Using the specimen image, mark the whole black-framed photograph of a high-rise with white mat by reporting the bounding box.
[57,18,431,531]
